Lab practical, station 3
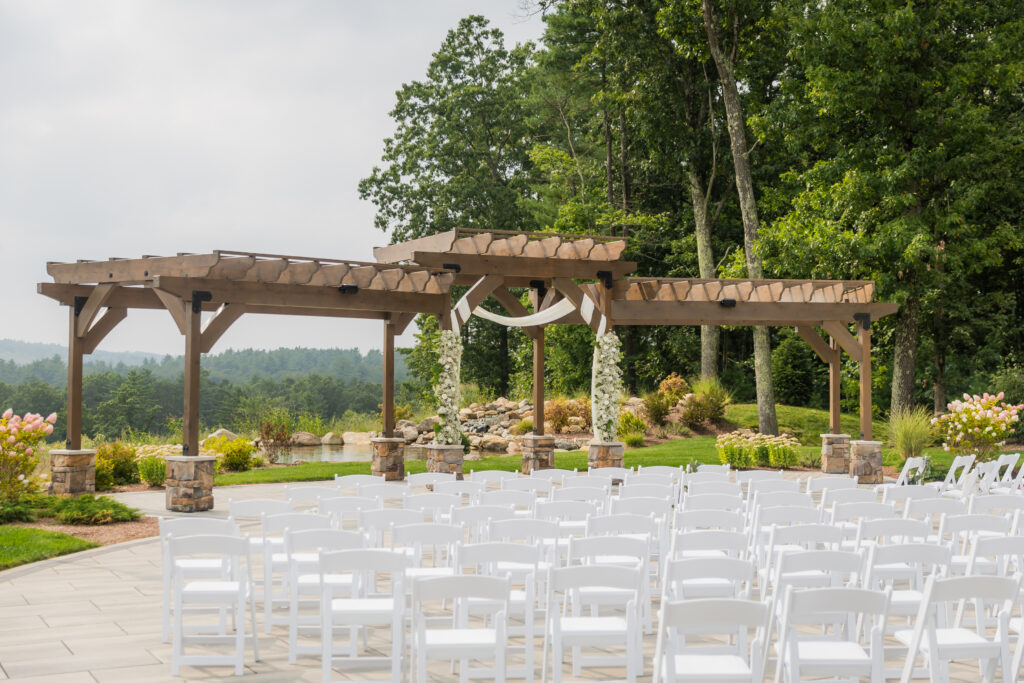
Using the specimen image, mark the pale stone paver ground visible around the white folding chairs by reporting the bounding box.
[0,473,978,683]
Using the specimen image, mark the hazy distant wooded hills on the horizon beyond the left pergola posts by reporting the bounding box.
[0,340,407,386]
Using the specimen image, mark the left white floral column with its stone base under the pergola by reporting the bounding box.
[427,330,465,478]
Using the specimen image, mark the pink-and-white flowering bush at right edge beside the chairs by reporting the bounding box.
[932,391,1024,461]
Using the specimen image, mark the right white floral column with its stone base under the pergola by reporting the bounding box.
[588,332,623,468]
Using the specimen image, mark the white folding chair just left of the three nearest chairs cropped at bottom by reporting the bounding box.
[542,564,646,683]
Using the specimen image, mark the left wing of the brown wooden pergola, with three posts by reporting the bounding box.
[38,251,454,456]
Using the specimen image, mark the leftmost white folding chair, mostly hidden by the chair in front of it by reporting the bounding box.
[158,517,239,643]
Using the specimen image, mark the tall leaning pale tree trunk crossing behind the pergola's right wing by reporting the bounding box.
[700,0,778,434]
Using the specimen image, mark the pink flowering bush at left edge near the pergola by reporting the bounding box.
[0,409,57,503]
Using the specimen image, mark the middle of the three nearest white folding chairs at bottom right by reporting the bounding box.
[775,588,889,683]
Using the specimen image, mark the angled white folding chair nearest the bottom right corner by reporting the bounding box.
[894,575,1021,683]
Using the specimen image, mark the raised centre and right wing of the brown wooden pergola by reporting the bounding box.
[374,228,897,439]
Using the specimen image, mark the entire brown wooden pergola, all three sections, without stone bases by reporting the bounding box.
[38,228,897,464]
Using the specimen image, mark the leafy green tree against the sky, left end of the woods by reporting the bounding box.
[358,15,532,242]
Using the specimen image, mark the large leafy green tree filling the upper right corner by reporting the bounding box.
[766,0,1024,410]
